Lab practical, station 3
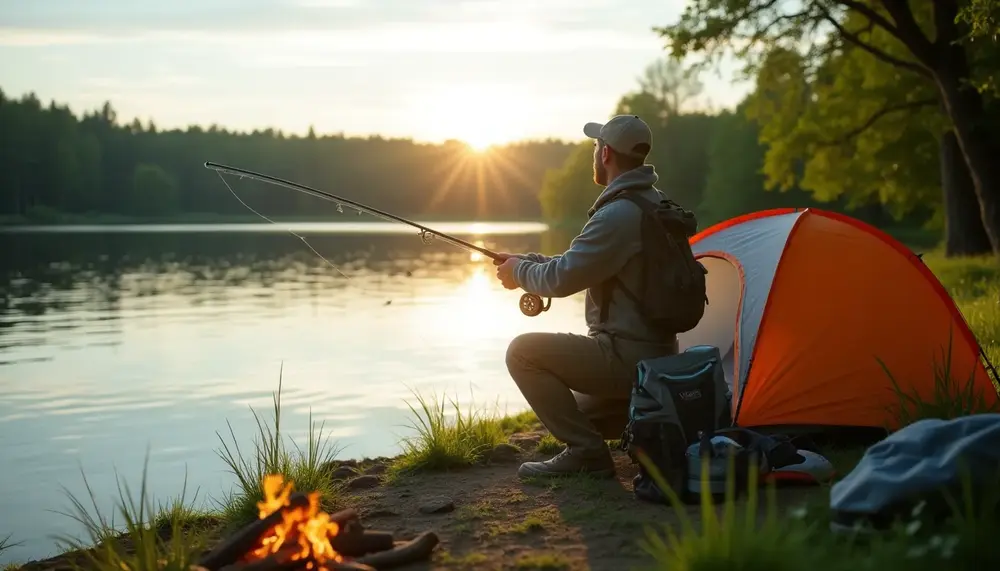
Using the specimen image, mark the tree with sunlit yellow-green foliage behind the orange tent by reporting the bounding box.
[747,38,992,255]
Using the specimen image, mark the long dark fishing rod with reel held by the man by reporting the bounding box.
[205,161,552,317]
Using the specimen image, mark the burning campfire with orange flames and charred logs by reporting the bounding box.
[194,474,438,571]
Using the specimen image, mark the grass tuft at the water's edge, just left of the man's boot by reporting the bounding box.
[390,393,534,477]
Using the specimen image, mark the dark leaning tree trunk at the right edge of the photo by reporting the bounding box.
[934,60,1000,254]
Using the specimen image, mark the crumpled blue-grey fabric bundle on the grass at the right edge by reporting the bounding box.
[830,414,1000,523]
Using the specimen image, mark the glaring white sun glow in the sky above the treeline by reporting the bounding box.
[413,85,532,153]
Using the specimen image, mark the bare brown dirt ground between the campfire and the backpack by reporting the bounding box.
[21,433,825,571]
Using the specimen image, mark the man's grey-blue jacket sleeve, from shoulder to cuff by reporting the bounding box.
[513,201,640,297]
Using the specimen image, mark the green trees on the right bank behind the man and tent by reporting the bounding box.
[541,0,1000,255]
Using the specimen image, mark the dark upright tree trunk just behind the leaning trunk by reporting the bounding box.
[940,131,992,257]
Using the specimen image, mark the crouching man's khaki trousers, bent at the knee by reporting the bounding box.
[507,333,677,450]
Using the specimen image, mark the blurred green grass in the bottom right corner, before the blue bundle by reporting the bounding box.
[640,450,1000,571]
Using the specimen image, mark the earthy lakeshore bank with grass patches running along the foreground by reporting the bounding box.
[5,398,996,571]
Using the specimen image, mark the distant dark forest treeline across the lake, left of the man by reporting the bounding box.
[0,93,572,222]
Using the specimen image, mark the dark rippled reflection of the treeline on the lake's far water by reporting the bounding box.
[0,228,572,365]
